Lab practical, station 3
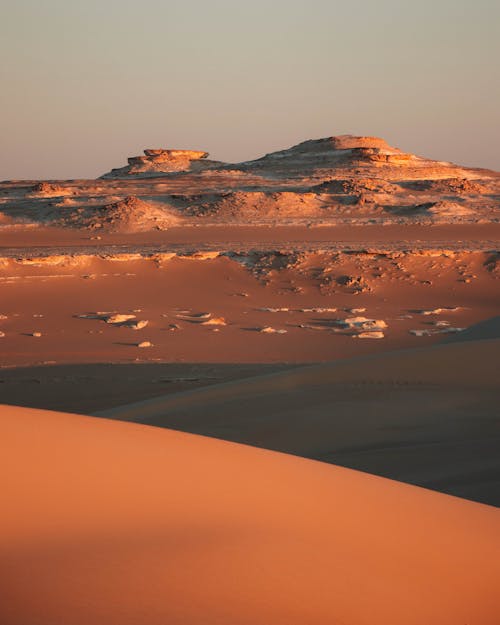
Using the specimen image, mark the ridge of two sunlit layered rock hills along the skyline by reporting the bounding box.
[102,135,491,186]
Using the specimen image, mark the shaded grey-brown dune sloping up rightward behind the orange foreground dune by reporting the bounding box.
[99,339,500,505]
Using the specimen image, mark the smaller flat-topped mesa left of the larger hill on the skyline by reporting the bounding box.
[102,148,223,178]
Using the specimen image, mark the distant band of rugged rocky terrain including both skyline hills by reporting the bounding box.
[0,135,500,232]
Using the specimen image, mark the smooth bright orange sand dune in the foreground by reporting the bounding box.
[0,406,500,625]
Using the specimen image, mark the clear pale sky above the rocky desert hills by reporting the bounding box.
[0,0,500,180]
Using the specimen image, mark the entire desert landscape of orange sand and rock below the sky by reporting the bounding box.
[0,135,500,625]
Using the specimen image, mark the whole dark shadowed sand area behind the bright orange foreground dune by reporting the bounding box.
[0,318,500,505]
